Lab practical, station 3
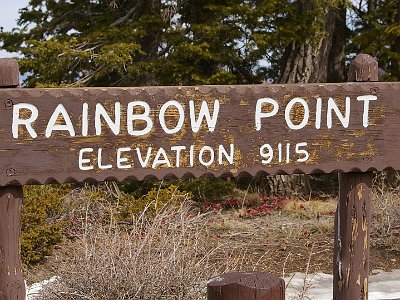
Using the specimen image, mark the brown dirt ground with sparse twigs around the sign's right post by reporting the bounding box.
[203,212,400,276]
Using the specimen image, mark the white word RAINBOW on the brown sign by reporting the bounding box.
[12,99,220,138]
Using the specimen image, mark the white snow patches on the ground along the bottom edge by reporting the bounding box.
[27,270,400,300]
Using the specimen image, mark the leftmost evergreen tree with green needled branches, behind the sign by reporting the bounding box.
[0,0,169,86]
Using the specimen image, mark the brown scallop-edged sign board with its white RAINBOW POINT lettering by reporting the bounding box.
[0,83,394,185]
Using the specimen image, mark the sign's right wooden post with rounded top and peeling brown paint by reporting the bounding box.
[333,54,378,300]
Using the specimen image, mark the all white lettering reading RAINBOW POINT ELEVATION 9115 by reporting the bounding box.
[11,95,378,171]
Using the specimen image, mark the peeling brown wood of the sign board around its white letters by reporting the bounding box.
[0,83,394,185]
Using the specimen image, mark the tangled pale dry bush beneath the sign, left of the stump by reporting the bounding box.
[39,185,250,300]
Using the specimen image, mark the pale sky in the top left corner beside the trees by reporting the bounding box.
[0,0,29,58]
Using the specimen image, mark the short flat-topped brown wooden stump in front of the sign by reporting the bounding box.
[207,272,285,300]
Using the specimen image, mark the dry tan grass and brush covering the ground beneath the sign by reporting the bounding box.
[28,175,400,300]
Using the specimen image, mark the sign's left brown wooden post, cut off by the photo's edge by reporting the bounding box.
[0,58,26,300]
